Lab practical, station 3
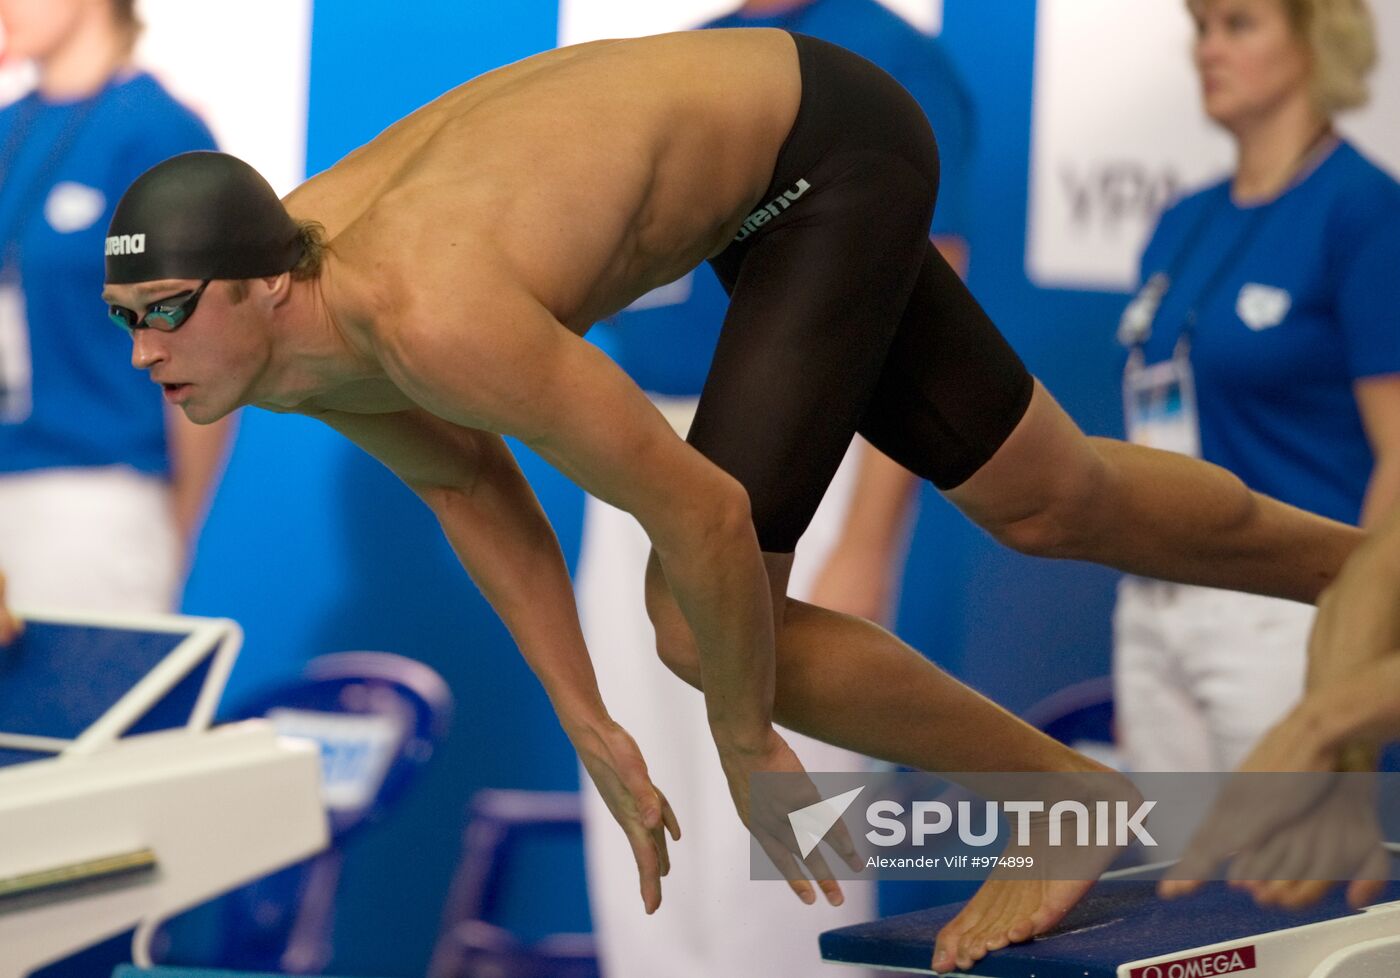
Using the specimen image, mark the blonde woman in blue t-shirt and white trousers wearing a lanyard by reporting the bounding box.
[1114,0,1400,771]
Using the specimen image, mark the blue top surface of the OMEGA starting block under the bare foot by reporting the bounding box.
[822,880,1400,978]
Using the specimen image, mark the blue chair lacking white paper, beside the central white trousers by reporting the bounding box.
[428,789,599,978]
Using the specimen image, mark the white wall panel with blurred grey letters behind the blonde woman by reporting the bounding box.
[1026,0,1400,291]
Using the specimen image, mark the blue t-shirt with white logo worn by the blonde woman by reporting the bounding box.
[1141,143,1400,523]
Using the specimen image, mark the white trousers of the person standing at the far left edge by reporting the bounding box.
[0,466,181,611]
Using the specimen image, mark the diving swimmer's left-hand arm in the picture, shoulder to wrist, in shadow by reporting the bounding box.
[318,410,606,732]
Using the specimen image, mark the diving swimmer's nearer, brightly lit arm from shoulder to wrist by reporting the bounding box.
[382,291,774,750]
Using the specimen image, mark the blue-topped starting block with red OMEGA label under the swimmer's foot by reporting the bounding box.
[822,880,1400,978]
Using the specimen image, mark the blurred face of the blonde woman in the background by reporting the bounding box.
[1190,0,1312,133]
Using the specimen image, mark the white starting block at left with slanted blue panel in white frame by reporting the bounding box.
[0,611,328,978]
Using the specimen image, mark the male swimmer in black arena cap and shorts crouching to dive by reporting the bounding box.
[105,29,1359,970]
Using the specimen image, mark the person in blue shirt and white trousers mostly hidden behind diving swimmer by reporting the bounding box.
[577,0,973,978]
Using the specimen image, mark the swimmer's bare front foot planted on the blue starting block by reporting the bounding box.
[932,768,1142,971]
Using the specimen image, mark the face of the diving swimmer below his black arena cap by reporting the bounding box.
[102,278,269,424]
